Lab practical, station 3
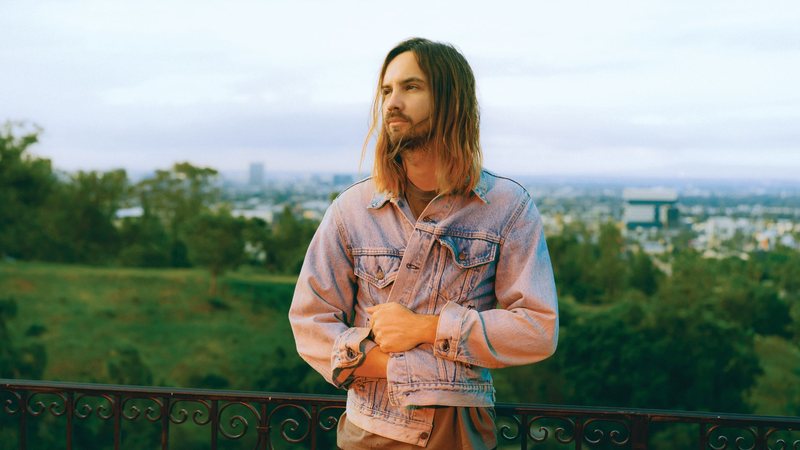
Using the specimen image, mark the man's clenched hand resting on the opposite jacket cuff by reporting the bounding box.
[367,303,439,353]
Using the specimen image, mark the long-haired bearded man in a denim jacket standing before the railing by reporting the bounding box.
[289,38,558,450]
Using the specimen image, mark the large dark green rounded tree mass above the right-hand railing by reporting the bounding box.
[557,301,760,412]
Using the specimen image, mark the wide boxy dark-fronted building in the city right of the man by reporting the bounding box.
[622,188,678,229]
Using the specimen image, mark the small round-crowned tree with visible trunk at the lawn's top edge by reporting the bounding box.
[184,210,244,295]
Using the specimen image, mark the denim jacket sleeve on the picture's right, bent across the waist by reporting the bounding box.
[434,193,558,368]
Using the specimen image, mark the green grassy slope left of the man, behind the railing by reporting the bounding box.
[0,263,294,389]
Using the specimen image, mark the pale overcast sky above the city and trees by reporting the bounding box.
[0,0,800,180]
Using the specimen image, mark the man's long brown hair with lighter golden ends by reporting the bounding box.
[361,38,483,195]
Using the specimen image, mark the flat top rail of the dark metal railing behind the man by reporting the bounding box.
[0,378,800,430]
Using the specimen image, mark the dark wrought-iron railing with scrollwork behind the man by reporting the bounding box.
[0,379,800,450]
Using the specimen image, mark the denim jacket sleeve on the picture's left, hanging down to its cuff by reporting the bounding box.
[289,202,376,389]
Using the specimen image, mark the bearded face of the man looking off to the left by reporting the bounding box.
[381,52,432,149]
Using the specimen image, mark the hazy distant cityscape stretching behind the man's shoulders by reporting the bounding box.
[222,163,800,259]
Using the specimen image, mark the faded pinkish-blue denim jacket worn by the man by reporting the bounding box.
[289,171,558,446]
